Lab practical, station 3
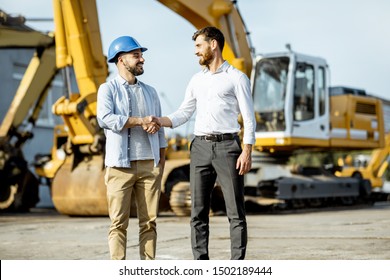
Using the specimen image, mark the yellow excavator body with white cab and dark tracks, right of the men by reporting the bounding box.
[246,53,390,207]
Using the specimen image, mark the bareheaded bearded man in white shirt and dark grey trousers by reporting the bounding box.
[160,27,255,260]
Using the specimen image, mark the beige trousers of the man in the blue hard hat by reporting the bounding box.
[105,160,161,260]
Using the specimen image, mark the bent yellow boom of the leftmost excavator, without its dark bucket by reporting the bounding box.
[0,10,57,138]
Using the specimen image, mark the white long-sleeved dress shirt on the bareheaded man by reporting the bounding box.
[168,61,256,145]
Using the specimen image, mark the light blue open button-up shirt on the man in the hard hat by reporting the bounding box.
[97,75,167,167]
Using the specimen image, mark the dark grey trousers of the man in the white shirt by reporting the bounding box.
[190,136,248,260]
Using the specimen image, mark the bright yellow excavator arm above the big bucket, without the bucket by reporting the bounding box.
[53,0,108,151]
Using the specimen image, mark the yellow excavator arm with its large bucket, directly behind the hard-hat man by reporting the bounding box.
[41,0,108,216]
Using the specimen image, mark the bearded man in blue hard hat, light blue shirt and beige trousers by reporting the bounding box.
[97,36,167,260]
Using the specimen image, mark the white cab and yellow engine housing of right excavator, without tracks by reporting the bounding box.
[252,51,384,155]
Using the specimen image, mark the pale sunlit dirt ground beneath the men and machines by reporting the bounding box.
[0,202,390,260]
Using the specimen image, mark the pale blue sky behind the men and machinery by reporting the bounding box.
[0,0,390,134]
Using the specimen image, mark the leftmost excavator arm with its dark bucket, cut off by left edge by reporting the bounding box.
[0,10,57,211]
